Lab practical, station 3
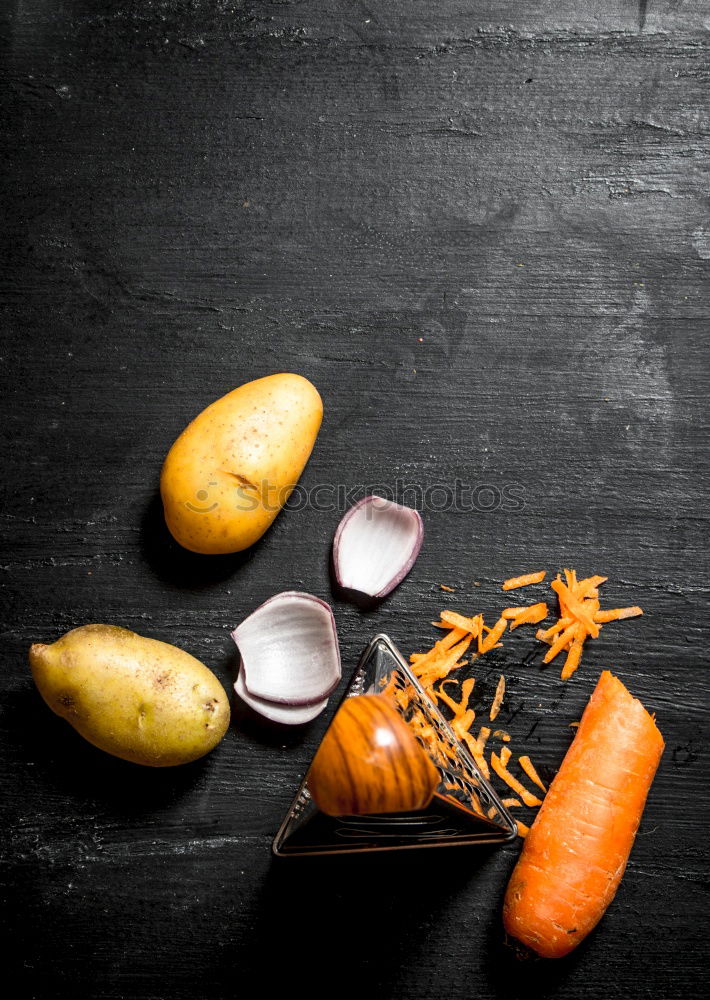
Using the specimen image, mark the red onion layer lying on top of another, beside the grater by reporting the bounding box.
[232,590,340,705]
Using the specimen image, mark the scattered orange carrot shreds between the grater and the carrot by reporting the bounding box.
[410,569,643,837]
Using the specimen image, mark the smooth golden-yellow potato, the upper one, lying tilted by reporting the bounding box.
[160,375,323,554]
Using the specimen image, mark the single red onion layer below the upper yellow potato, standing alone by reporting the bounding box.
[333,496,424,597]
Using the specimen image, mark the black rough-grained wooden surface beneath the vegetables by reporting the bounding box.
[0,0,710,1000]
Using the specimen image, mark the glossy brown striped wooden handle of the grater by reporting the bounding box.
[308,694,439,816]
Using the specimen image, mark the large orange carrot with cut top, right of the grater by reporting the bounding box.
[503,670,663,958]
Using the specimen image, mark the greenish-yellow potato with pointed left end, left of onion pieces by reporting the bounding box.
[30,625,230,767]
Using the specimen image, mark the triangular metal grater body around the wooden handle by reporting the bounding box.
[273,635,517,857]
